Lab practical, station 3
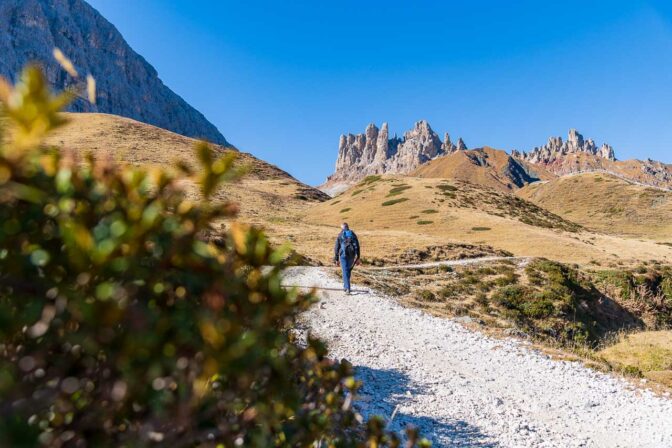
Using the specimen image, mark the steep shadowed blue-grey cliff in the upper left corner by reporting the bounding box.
[0,0,228,146]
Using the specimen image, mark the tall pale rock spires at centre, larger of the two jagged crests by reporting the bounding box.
[327,120,467,183]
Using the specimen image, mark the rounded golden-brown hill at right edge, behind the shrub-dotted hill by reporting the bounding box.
[517,173,672,242]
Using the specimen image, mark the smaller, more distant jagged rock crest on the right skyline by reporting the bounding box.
[512,129,616,165]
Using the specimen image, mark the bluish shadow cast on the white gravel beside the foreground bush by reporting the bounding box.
[355,366,499,448]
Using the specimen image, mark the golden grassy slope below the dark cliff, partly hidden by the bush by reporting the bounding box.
[47,114,327,224]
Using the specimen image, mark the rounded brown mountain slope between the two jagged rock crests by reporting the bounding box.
[411,146,555,191]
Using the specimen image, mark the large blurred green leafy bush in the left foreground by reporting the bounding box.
[0,68,430,447]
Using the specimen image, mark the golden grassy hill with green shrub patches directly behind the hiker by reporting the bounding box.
[297,176,672,264]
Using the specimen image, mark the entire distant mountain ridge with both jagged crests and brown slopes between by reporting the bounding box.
[319,120,672,195]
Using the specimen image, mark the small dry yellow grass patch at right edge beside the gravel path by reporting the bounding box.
[599,331,672,387]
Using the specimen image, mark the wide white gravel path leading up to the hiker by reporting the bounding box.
[285,267,672,448]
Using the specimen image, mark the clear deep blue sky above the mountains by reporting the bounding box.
[90,0,672,185]
